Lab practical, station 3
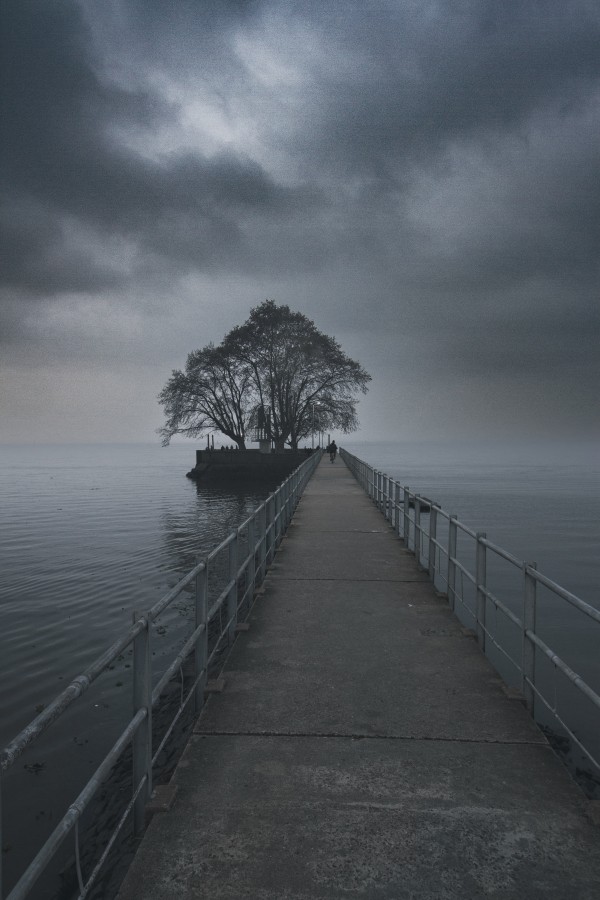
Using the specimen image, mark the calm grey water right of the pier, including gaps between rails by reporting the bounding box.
[345,441,600,796]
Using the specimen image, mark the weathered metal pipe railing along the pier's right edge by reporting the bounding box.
[340,449,600,771]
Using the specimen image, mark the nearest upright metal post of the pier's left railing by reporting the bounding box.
[133,612,152,835]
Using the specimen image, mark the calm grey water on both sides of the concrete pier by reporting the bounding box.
[0,440,600,896]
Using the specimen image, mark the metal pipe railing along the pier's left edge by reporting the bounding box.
[0,452,321,900]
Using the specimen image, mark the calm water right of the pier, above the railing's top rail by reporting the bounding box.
[343,440,600,607]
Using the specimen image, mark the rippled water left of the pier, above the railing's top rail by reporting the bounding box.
[0,446,282,743]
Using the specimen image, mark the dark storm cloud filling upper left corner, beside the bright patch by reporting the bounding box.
[0,3,324,306]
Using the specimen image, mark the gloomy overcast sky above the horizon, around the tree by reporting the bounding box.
[0,0,600,442]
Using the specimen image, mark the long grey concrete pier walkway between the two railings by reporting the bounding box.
[119,458,600,900]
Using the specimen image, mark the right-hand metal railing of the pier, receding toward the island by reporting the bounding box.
[340,449,600,774]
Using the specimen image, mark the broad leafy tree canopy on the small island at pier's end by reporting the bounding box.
[159,300,371,449]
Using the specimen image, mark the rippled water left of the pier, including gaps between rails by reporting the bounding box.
[0,446,286,897]
